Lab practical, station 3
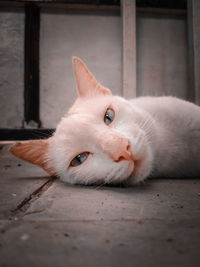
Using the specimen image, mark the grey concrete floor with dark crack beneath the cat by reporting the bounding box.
[0,144,200,267]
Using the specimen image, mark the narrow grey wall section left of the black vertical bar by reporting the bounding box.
[0,8,24,128]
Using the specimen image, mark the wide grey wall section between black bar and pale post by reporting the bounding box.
[40,11,122,127]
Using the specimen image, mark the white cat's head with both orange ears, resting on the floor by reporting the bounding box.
[11,58,152,184]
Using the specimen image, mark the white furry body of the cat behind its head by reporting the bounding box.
[131,97,200,180]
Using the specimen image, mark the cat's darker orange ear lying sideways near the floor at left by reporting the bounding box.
[10,139,55,175]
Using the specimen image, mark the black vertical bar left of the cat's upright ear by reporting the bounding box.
[24,4,41,127]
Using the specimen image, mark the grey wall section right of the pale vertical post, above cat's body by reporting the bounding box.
[137,14,188,99]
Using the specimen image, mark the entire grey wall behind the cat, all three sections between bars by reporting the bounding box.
[0,9,189,128]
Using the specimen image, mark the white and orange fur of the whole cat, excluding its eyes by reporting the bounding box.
[11,58,200,184]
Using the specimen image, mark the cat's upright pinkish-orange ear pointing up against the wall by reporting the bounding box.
[73,57,112,97]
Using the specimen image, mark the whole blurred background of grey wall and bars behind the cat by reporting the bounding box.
[0,0,200,140]
